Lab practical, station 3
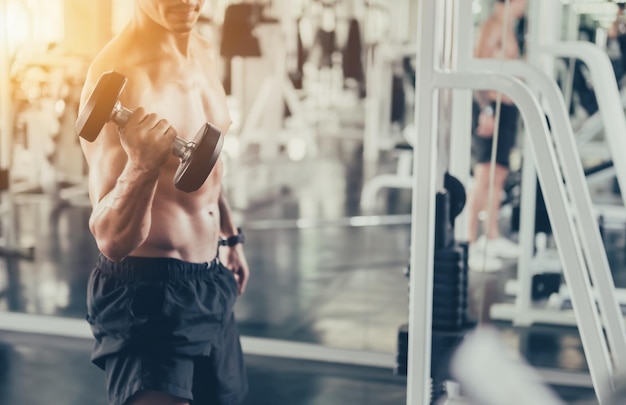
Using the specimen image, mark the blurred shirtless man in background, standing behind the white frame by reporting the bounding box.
[468,0,526,271]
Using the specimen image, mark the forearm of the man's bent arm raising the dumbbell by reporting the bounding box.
[90,164,159,260]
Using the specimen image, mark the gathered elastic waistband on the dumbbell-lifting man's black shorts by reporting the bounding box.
[97,254,219,281]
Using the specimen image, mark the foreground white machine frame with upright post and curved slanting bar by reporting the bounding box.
[407,0,626,405]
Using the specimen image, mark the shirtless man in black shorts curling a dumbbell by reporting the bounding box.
[81,0,249,405]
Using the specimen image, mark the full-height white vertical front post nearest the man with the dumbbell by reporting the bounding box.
[407,0,440,405]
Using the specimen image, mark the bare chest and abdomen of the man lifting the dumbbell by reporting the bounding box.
[92,29,230,262]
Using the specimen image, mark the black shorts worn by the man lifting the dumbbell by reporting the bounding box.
[87,256,248,405]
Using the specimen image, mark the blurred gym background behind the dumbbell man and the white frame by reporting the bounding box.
[0,0,626,405]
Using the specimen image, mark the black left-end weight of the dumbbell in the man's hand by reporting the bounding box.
[75,71,126,142]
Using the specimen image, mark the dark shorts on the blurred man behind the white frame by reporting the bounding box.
[472,103,519,168]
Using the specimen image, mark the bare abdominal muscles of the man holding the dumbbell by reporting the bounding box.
[130,156,222,263]
